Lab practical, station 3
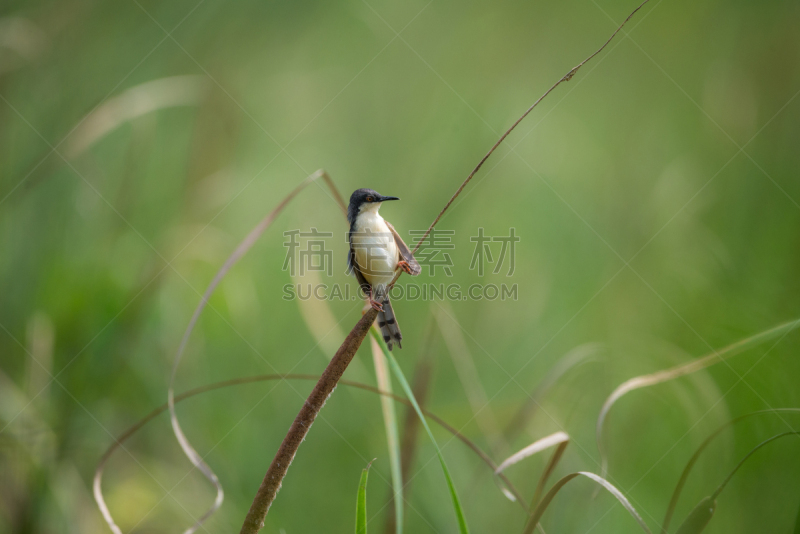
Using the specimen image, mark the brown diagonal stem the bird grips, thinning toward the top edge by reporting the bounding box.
[240,0,649,534]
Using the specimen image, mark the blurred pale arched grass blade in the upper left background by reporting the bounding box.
[64,74,207,158]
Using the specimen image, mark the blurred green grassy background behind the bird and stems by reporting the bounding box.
[0,0,800,534]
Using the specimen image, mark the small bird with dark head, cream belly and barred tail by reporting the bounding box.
[347,189,422,350]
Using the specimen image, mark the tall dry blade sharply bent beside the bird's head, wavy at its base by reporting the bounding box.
[167,169,343,534]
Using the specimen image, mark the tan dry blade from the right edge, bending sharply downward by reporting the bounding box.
[596,319,800,482]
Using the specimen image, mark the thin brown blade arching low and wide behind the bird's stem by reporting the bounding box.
[93,374,527,534]
